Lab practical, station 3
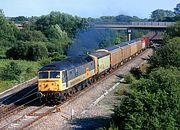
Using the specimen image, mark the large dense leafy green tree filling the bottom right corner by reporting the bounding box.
[114,68,180,130]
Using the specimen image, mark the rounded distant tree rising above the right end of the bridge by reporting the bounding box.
[151,9,175,21]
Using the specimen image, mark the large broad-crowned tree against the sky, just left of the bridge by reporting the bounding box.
[35,12,88,37]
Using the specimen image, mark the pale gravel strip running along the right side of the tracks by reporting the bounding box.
[29,49,152,130]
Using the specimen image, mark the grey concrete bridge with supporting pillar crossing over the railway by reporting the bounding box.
[94,22,175,40]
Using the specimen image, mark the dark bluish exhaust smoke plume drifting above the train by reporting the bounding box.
[67,28,117,57]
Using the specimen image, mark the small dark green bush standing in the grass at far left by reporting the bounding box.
[0,61,22,80]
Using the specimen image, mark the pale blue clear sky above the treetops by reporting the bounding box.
[0,0,180,18]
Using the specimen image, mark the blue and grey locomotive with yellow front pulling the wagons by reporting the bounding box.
[38,56,96,101]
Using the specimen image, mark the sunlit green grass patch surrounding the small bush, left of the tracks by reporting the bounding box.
[0,59,40,92]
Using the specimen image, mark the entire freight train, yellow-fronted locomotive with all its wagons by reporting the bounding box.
[38,36,150,102]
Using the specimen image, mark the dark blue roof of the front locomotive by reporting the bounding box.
[39,56,93,71]
